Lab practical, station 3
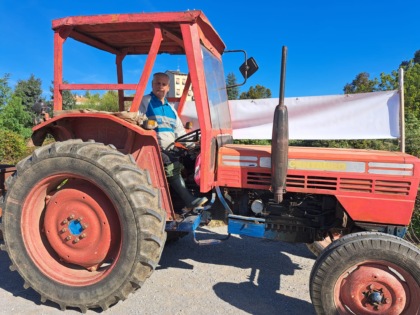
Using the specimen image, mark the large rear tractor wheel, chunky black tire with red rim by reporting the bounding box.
[2,140,166,312]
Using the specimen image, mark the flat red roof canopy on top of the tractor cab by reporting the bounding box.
[52,10,225,55]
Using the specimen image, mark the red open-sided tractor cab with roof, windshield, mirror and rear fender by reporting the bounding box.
[33,11,258,220]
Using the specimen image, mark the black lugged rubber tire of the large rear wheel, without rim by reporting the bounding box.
[0,139,166,312]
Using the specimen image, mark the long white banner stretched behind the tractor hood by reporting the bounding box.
[181,91,400,140]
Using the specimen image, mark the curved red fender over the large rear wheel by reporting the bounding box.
[32,113,175,220]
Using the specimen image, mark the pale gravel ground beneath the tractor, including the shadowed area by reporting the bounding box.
[0,227,315,315]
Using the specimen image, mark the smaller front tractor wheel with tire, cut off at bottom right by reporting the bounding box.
[310,232,420,315]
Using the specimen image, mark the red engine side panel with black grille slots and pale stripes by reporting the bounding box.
[217,145,420,225]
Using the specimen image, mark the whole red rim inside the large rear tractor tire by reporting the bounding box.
[21,174,122,286]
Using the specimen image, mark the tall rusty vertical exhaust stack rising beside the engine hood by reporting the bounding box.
[271,46,289,203]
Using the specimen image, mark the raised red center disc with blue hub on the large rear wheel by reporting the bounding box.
[44,185,115,271]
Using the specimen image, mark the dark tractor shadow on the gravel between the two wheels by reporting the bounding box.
[158,230,315,315]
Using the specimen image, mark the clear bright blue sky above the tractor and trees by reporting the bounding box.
[0,0,420,99]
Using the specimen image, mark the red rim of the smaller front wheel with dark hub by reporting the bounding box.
[334,261,420,315]
